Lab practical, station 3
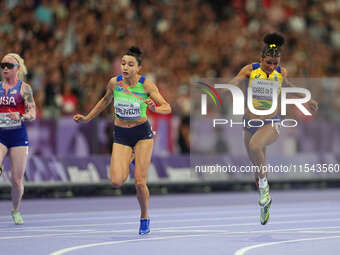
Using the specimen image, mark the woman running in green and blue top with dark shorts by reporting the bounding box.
[73,47,171,235]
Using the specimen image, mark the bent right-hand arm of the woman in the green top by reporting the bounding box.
[144,80,171,114]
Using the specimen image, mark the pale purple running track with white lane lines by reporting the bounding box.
[0,189,340,255]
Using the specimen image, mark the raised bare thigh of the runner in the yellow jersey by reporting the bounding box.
[250,124,279,148]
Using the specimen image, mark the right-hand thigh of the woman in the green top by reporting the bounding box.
[135,139,153,182]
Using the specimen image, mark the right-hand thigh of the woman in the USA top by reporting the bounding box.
[9,146,28,178]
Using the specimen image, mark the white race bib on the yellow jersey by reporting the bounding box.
[251,80,279,101]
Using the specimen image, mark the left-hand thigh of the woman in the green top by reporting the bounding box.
[110,143,132,180]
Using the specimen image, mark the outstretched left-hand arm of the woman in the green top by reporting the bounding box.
[73,77,116,122]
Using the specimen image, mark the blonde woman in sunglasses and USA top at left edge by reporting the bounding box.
[0,53,36,224]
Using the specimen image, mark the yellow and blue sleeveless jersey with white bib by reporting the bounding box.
[247,63,283,110]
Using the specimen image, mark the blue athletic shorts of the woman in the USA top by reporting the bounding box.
[0,123,29,149]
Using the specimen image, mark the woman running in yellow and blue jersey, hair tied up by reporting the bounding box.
[230,33,318,225]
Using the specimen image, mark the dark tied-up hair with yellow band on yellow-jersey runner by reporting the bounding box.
[262,33,285,58]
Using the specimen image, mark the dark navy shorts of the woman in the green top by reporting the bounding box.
[113,121,153,148]
